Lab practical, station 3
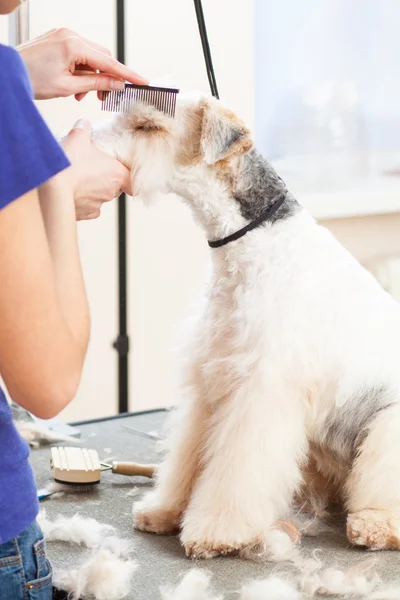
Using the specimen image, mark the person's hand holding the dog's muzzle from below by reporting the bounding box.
[62,119,131,221]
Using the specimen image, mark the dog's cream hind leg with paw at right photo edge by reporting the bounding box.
[346,403,400,550]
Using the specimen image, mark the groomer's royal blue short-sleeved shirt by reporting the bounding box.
[0,44,69,544]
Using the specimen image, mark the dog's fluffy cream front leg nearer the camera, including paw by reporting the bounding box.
[181,383,305,558]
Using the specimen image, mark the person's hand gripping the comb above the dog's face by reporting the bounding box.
[17,28,148,100]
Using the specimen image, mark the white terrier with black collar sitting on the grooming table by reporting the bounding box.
[96,98,400,558]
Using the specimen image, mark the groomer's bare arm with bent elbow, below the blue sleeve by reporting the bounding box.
[0,180,89,419]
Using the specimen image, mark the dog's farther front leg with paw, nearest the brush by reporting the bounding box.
[133,386,207,534]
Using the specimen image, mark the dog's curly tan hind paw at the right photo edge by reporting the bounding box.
[347,510,400,550]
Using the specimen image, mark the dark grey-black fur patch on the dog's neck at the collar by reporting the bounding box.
[233,149,300,221]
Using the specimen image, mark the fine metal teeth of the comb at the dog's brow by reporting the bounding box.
[101,83,179,117]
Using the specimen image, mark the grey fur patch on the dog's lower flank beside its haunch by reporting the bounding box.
[320,386,393,463]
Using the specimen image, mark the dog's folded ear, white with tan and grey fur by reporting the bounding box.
[200,98,253,165]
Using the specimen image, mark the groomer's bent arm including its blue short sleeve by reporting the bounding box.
[0,46,89,418]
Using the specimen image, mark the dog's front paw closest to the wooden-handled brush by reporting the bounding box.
[133,497,181,535]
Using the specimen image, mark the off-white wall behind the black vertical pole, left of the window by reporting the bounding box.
[0,0,253,420]
